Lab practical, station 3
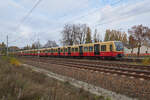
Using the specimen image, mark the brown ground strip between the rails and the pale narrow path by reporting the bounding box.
[21,57,150,100]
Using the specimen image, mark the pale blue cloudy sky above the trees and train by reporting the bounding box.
[0,0,150,47]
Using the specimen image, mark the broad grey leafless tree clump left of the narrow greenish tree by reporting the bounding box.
[61,24,88,45]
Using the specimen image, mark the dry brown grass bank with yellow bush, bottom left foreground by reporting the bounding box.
[0,57,104,100]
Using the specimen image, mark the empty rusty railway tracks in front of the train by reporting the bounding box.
[20,58,150,80]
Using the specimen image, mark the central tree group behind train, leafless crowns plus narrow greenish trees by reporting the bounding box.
[61,24,101,46]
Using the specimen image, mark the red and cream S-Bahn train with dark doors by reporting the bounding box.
[17,41,124,58]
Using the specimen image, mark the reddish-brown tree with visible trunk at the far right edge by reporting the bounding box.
[128,25,150,56]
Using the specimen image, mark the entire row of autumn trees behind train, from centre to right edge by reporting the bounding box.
[61,24,150,55]
